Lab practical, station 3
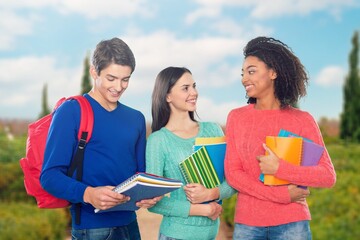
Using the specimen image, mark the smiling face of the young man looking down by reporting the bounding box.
[90,63,131,111]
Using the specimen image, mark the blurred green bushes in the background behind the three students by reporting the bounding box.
[0,125,360,240]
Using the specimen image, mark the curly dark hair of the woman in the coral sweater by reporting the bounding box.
[244,37,308,108]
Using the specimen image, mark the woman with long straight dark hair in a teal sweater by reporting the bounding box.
[146,67,235,240]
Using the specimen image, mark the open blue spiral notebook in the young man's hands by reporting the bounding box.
[95,172,182,213]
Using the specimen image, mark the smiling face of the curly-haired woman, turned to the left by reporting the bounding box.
[241,56,276,101]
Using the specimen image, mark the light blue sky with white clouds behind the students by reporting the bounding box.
[0,0,360,124]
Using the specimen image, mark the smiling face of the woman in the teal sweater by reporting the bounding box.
[166,72,198,112]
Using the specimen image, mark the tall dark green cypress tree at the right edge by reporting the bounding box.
[340,32,360,142]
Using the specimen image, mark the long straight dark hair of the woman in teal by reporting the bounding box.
[151,67,196,132]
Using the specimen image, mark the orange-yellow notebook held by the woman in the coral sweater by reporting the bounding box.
[264,136,303,186]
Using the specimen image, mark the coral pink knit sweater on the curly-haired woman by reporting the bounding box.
[225,104,336,226]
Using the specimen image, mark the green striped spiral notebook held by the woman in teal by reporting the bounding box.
[179,146,220,188]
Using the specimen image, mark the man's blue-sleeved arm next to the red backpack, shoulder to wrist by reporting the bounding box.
[40,101,87,203]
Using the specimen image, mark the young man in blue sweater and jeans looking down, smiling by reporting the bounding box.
[40,38,161,240]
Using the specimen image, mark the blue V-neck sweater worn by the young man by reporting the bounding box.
[40,94,146,229]
